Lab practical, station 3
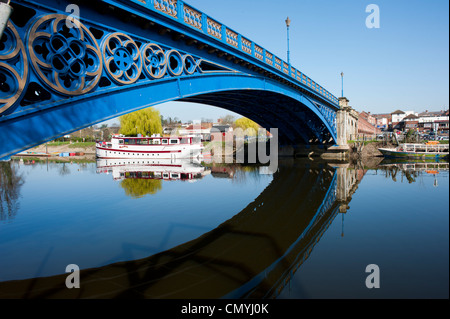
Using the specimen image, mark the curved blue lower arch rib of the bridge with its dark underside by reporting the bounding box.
[0,72,335,157]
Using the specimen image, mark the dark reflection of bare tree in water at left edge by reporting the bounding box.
[0,162,24,221]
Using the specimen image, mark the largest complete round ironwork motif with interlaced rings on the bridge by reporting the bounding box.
[28,14,103,95]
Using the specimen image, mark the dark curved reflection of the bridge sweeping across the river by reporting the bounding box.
[0,161,362,299]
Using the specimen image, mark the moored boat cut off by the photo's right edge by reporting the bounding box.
[378,143,449,159]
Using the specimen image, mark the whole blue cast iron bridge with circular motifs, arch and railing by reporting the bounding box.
[0,0,339,158]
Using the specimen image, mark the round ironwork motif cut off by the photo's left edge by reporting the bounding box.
[0,22,28,114]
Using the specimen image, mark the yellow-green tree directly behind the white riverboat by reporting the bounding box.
[119,108,162,136]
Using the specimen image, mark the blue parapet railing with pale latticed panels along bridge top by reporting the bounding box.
[123,0,338,105]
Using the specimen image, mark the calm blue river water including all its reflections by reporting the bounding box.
[0,159,449,299]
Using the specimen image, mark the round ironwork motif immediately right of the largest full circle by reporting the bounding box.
[103,32,142,84]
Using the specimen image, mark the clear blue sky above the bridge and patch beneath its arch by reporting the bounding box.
[107,0,449,121]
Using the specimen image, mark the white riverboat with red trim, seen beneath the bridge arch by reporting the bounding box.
[96,135,203,159]
